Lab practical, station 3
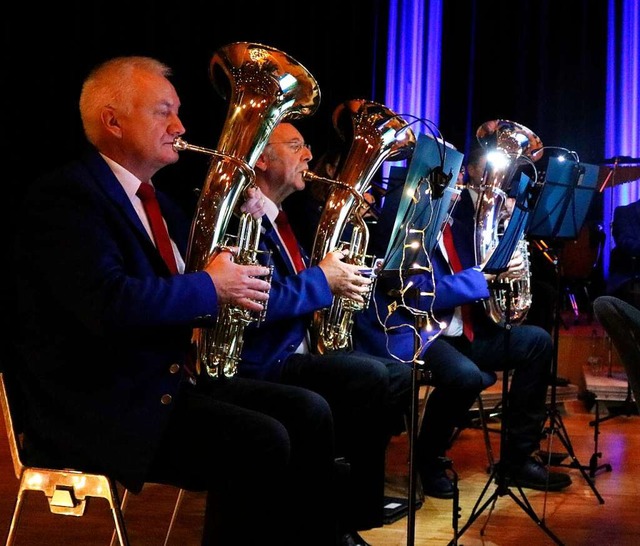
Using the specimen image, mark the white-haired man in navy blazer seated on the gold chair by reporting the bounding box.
[7,57,337,546]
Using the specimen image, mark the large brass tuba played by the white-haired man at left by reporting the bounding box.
[174,42,320,377]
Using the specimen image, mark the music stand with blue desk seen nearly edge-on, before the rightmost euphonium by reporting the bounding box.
[449,175,563,546]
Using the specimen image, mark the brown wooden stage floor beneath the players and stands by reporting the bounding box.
[0,312,640,546]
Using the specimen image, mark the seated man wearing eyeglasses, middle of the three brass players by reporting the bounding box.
[238,123,411,546]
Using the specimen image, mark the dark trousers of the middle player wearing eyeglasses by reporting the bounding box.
[282,351,412,530]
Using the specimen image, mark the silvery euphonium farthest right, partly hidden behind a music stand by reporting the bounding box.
[475,119,542,324]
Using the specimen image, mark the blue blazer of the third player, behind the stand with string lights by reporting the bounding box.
[353,191,489,361]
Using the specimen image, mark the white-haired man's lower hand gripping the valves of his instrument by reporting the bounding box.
[205,247,271,312]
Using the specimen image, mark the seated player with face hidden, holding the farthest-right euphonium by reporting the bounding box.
[354,147,571,499]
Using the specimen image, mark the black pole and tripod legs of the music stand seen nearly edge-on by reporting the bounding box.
[449,281,563,546]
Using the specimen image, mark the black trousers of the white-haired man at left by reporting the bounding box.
[148,377,338,546]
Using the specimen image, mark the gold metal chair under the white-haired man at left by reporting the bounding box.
[0,372,184,546]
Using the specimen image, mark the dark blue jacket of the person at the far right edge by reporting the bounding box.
[607,201,640,294]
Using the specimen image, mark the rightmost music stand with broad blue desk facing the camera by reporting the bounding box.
[527,157,611,504]
